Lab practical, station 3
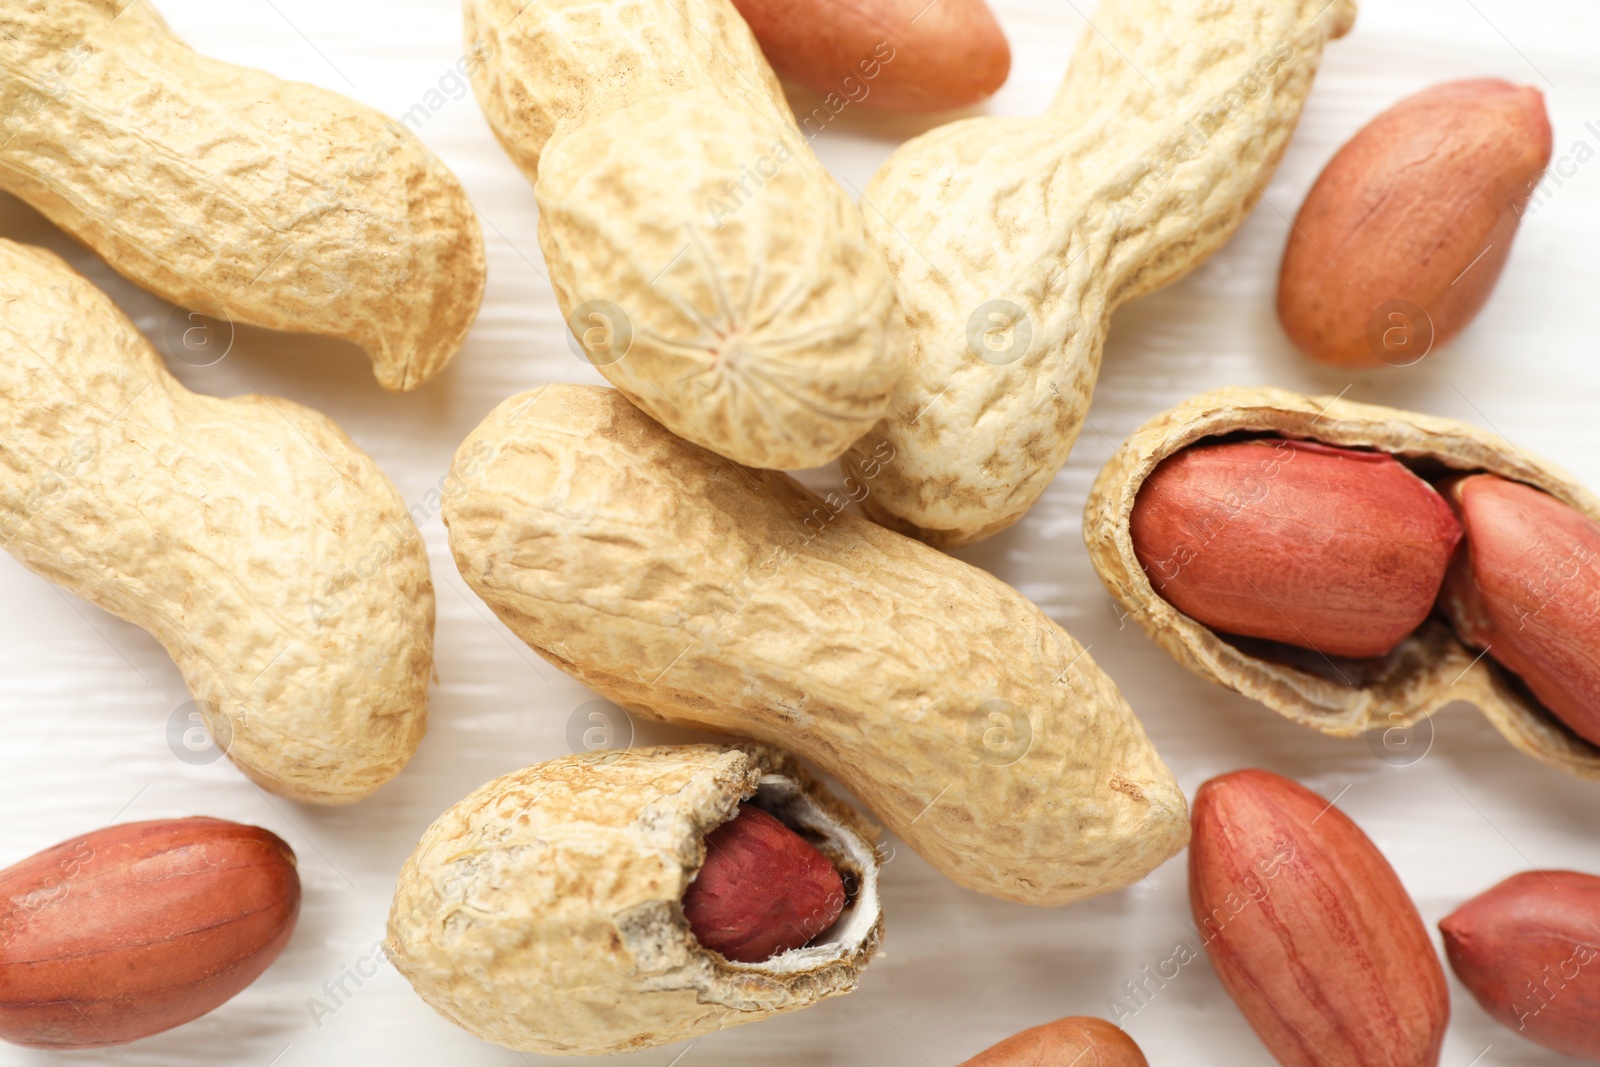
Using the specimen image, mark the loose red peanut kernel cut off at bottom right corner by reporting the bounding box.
[1438,870,1600,1064]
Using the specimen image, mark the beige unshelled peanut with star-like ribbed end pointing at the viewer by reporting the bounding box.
[466,0,906,469]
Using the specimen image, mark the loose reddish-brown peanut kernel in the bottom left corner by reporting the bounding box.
[0,817,301,1049]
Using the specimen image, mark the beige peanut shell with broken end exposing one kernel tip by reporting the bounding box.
[387,744,883,1056]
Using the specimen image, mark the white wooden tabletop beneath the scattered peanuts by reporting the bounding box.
[0,0,1600,1067]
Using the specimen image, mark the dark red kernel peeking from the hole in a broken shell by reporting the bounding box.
[683,805,845,963]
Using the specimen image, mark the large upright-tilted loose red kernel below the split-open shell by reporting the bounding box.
[1189,771,1450,1067]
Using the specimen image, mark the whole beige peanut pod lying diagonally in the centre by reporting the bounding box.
[445,386,1189,904]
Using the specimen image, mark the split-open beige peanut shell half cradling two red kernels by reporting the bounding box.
[1083,389,1600,777]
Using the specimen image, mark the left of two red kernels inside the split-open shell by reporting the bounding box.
[1131,438,1461,657]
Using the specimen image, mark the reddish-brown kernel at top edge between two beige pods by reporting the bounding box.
[733,0,1011,111]
